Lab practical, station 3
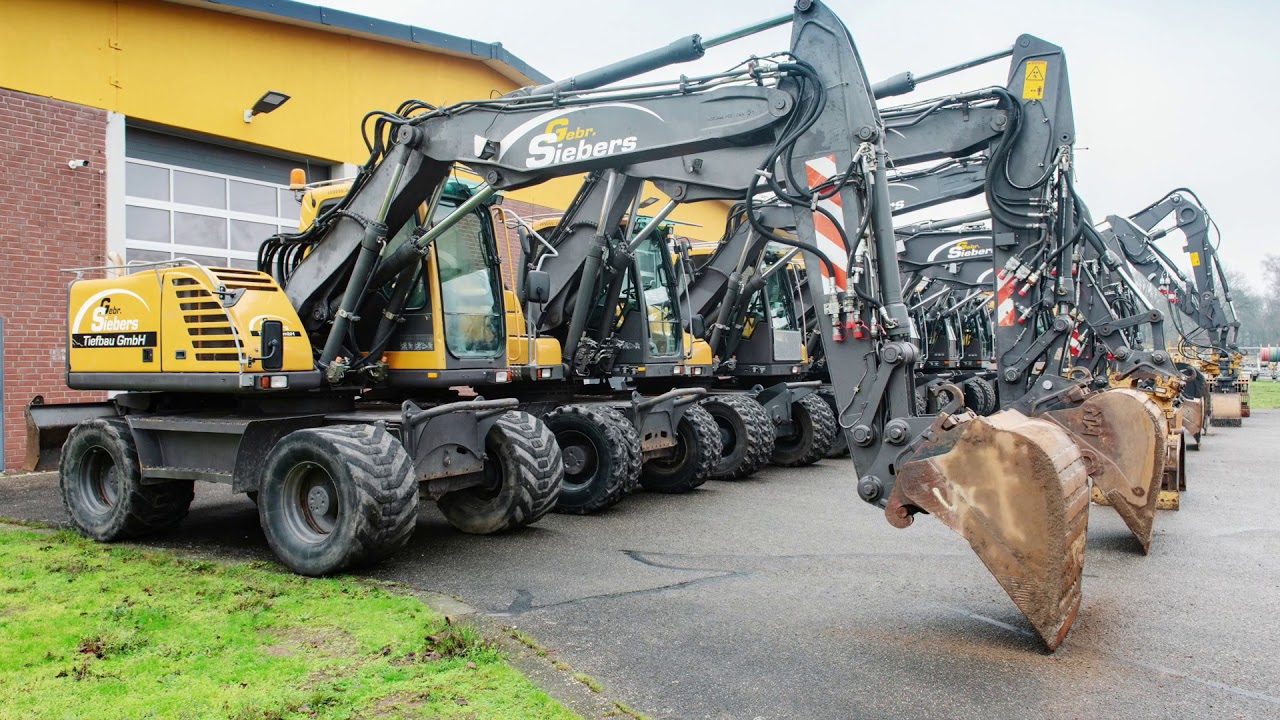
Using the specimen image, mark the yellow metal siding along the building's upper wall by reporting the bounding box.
[0,0,724,240]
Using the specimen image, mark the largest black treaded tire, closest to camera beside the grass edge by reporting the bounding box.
[257,424,419,577]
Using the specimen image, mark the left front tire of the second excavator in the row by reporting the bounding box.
[543,405,640,515]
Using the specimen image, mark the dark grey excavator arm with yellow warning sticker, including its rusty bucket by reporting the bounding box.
[883,35,1180,551]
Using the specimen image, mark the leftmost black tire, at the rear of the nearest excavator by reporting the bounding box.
[58,418,195,542]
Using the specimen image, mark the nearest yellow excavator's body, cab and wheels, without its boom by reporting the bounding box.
[28,163,563,575]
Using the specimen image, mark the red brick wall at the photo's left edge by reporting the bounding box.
[0,88,106,469]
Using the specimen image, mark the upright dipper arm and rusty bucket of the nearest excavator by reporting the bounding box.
[751,16,1088,648]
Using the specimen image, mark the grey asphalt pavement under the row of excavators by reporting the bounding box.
[0,411,1280,720]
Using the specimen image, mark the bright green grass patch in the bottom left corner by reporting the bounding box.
[0,530,576,720]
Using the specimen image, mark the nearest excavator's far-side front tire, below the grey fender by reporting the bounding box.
[436,410,564,536]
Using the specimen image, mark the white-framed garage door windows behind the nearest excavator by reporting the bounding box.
[124,158,302,269]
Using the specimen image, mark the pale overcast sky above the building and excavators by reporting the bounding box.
[312,0,1280,292]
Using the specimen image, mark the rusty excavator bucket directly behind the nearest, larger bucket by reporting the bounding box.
[1042,389,1169,555]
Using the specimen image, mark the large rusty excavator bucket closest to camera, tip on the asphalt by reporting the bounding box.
[884,410,1089,651]
